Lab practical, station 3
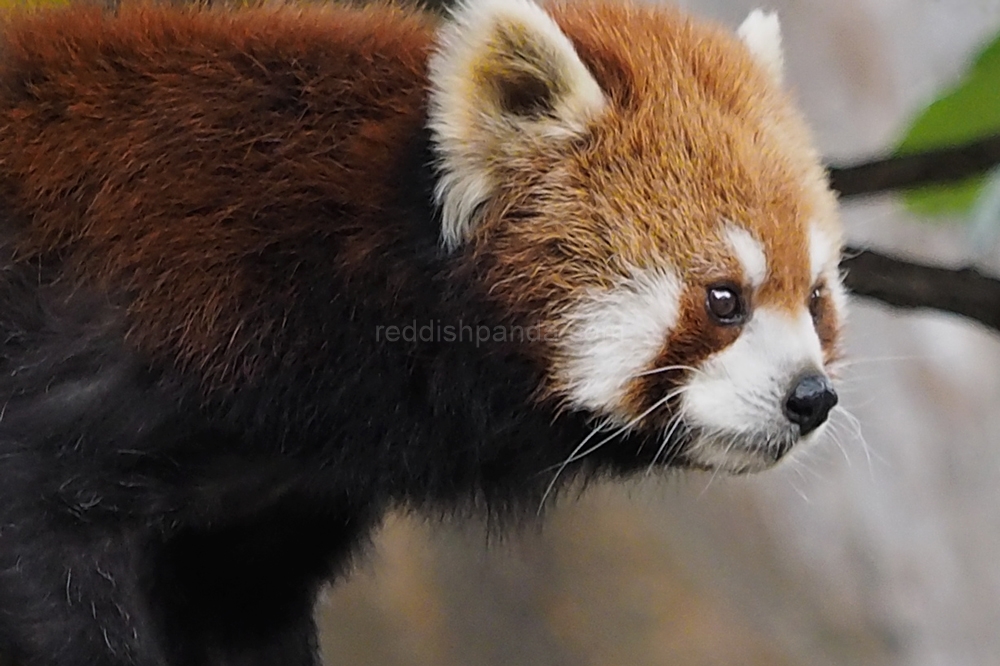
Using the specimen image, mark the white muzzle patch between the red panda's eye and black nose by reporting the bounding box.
[681,308,823,434]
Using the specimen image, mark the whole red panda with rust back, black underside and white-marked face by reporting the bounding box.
[0,0,844,666]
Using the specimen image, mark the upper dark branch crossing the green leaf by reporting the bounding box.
[830,135,1000,197]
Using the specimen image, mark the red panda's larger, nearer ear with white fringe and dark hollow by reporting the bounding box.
[428,0,606,249]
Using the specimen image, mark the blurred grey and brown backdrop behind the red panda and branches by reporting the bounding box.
[320,0,1000,666]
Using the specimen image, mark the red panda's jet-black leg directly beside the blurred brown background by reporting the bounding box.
[151,499,371,666]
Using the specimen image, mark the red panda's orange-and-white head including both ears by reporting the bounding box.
[429,0,845,472]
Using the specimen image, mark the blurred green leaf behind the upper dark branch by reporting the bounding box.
[896,34,1000,215]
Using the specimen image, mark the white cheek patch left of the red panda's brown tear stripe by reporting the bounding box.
[559,269,683,415]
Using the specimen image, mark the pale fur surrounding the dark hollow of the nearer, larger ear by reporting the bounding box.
[428,0,606,250]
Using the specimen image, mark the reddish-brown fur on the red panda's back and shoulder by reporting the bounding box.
[0,2,432,381]
